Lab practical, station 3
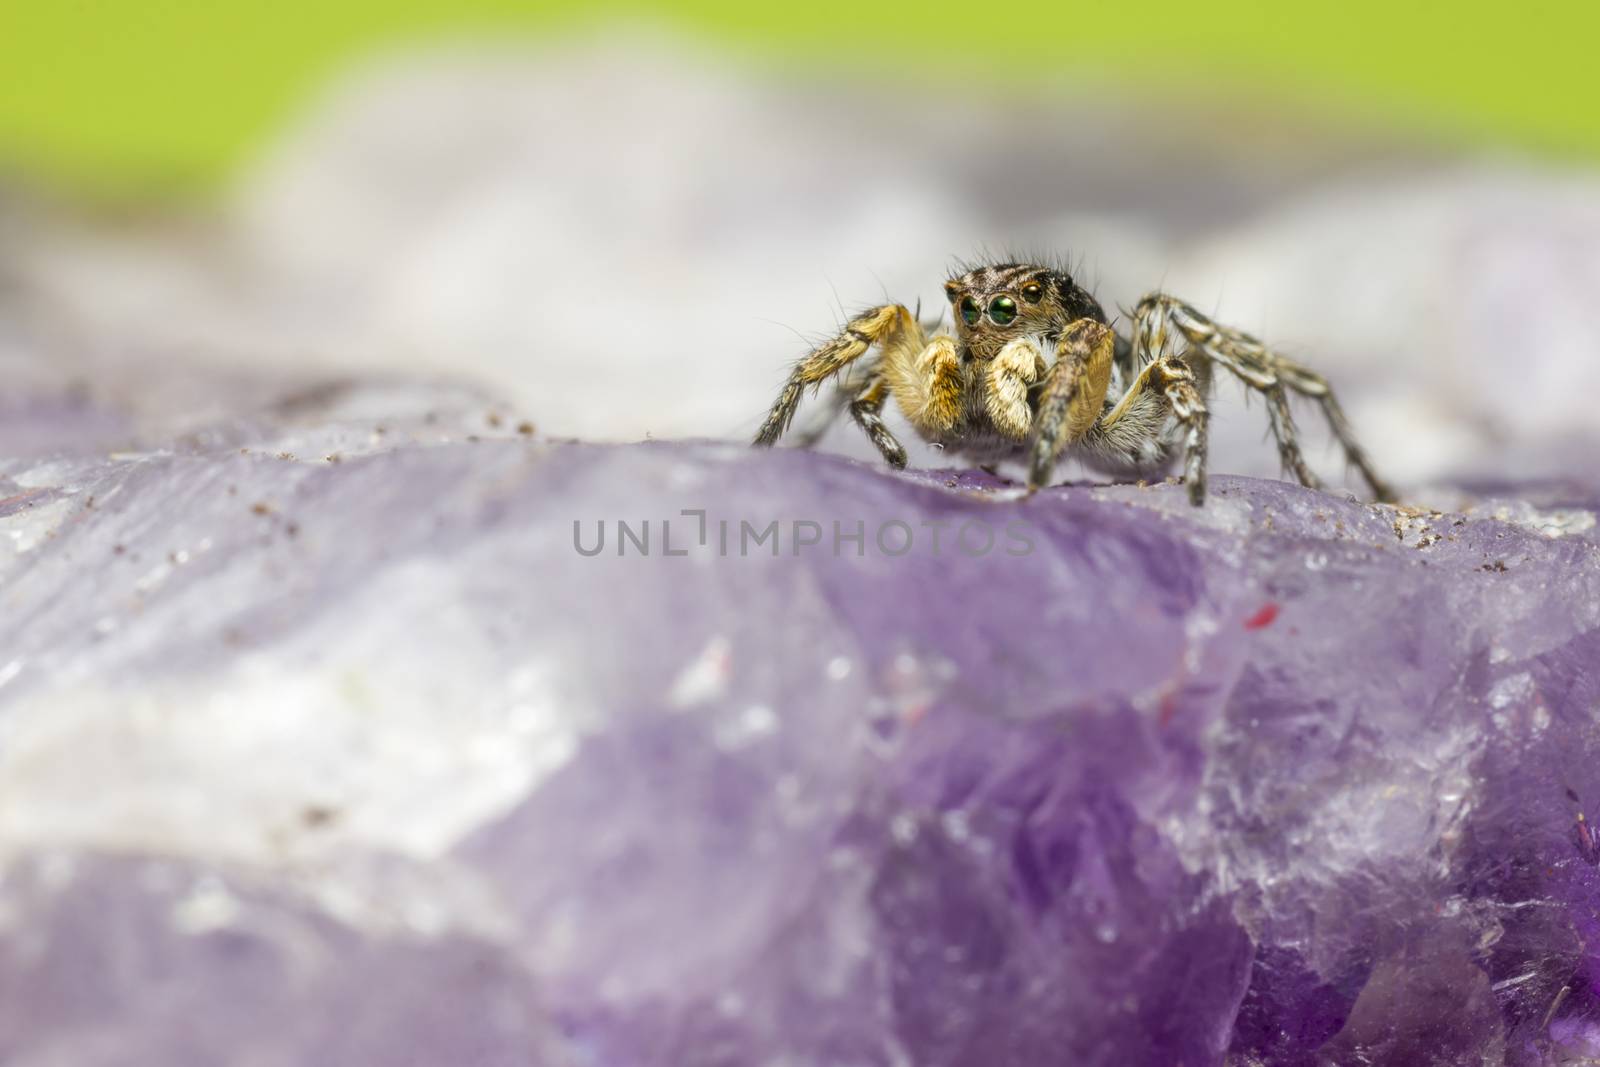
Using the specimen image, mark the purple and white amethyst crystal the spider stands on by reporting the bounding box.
[0,387,1600,1067]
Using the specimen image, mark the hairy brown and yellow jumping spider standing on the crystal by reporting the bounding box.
[755,262,1394,506]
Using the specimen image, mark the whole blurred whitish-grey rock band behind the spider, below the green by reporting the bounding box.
[0,35,1600,483]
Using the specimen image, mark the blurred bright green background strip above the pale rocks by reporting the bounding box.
[0,0,1600,192]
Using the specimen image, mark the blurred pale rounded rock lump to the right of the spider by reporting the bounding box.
[1171,165,1600,478]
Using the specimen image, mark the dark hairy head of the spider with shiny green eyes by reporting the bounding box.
[944,262,1106,360]
